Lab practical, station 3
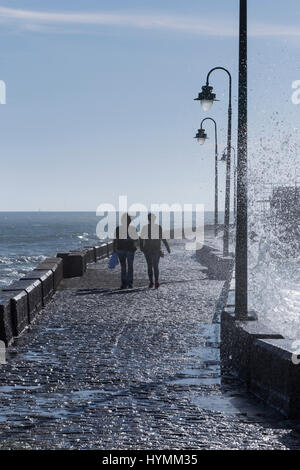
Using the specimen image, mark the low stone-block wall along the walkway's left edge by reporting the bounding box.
[0,242,113,346]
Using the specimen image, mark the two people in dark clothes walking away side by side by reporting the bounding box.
[114,214,171,289]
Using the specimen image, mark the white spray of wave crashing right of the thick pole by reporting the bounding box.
[249,121,300,338]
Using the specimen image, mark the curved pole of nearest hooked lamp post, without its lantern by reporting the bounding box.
[206,67,232,256]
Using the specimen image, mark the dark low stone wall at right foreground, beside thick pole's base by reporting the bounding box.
[221,283,300,419]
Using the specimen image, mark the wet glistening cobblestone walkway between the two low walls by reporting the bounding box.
[0,242,300,450]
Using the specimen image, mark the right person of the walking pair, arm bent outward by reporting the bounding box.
[140,214,171,289]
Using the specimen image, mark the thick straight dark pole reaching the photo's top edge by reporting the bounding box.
[235,0,248,320]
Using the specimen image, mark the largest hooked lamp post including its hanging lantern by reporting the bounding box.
[195,67,232,256]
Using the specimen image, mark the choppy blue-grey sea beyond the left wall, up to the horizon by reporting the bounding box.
[0,212,223,288]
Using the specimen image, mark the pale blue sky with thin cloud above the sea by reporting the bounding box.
[0,0,300,211]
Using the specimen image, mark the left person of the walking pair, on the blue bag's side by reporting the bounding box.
[113,214,138,289]
